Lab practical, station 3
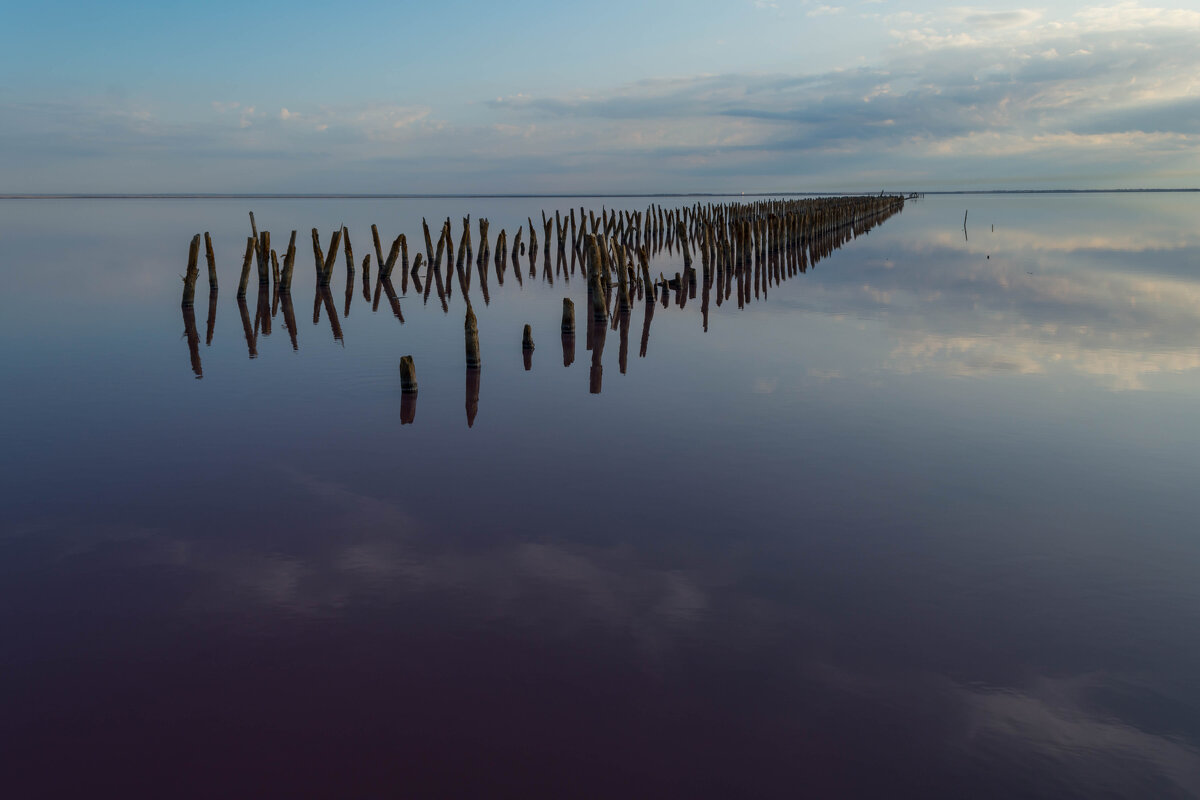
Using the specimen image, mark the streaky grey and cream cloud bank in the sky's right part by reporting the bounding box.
[465,4,1200,185]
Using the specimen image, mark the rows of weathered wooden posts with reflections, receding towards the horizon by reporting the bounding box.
[182,196,905,400]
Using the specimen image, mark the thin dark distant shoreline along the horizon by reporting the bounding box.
[0,188,1200,200]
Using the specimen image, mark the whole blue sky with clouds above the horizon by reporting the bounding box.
[0,0,1200,193]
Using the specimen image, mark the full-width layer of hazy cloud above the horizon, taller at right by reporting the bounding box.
[0,2,1200,192]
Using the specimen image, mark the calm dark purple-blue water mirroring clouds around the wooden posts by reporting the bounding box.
[0,194,1200,798]
